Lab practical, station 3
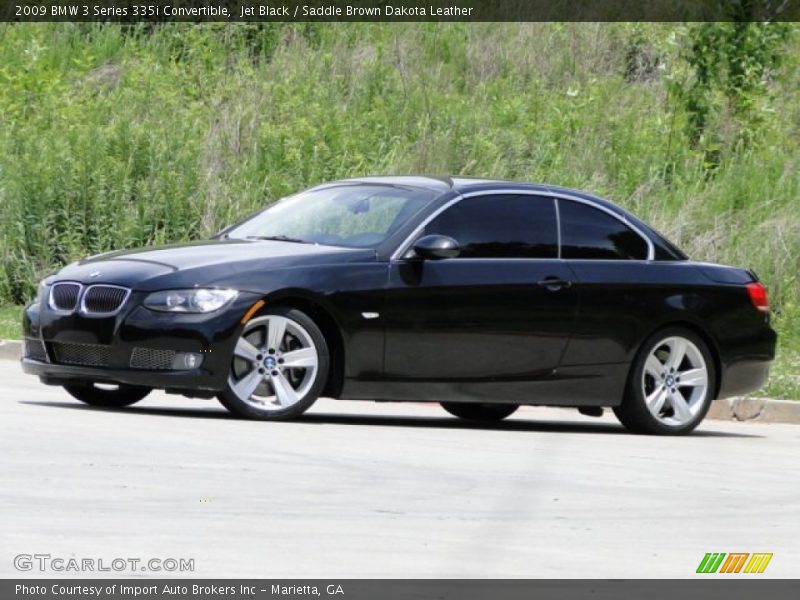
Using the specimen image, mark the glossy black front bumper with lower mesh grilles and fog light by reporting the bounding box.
[22,292,258,395]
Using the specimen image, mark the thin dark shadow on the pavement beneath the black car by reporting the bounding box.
[20,400,764,438]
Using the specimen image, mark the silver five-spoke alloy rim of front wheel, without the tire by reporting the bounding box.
[228,315,319,411]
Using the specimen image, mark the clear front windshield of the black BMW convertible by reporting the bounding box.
[227,184,436,248]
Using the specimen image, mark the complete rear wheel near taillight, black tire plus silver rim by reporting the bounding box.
[614,327,716,435]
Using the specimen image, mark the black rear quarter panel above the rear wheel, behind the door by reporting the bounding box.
[562,261,775,376]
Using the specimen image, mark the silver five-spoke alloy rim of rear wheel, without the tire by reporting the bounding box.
[642,336,709,427]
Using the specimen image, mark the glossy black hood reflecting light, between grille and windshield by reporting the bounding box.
[53,240,376,290]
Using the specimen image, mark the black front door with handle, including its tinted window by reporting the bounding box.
[384,195,578,401]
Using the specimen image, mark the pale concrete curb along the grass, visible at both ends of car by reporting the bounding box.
[0,340,800,423]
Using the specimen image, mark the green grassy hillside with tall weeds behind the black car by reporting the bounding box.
[0,24,800,397]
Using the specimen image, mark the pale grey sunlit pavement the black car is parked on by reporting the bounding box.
[0,361,800,578]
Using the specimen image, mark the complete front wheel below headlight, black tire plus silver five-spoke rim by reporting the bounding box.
[217,307,330,421]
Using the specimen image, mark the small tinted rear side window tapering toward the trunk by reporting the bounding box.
[558,200,647,260]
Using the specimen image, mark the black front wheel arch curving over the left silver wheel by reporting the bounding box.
[244,290,345,398]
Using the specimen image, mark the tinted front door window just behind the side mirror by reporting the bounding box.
[425,195,558,258]
